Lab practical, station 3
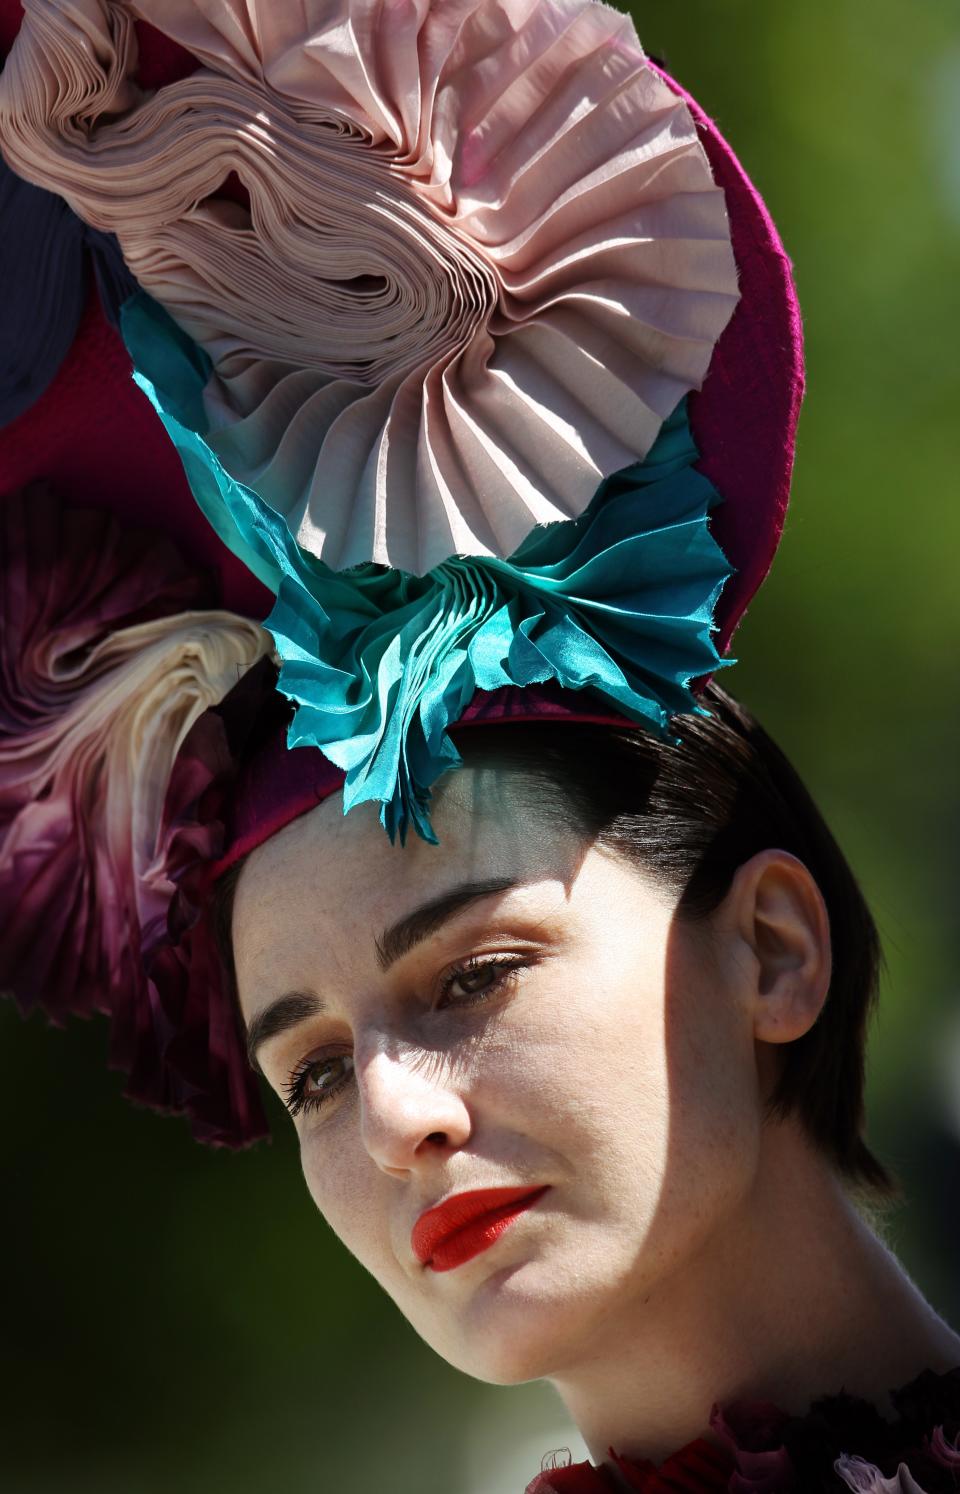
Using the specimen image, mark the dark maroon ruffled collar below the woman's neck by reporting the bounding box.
[527,1367,960,1494]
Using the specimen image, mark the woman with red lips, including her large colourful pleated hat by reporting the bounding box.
[0,0,960,1494]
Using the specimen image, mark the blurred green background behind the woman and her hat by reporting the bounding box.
[0,0,960,1494]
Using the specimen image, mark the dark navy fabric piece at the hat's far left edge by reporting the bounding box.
[0,157,139,427]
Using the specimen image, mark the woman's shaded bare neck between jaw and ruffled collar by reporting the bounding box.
[551,1122,960,1463]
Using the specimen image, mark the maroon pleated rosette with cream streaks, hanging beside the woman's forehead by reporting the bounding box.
[0,487,267,1141]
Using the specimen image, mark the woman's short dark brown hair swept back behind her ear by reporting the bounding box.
[213,683,897,1198]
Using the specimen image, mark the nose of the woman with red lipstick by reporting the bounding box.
[357,1049,470,1176]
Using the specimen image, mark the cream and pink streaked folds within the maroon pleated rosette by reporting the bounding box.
[0,600,273,974]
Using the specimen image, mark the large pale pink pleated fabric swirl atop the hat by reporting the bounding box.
[0,0,738,572]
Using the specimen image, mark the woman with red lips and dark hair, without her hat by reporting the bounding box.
[206,686,960,1491]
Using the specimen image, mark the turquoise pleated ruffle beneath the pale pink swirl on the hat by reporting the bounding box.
[121,293,733,841]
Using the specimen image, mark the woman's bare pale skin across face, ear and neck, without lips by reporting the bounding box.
[233,768,960,1463]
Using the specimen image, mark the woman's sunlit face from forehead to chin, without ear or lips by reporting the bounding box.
[233,768,761,1383]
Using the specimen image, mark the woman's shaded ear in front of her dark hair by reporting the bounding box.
[724,850,832,1043]
